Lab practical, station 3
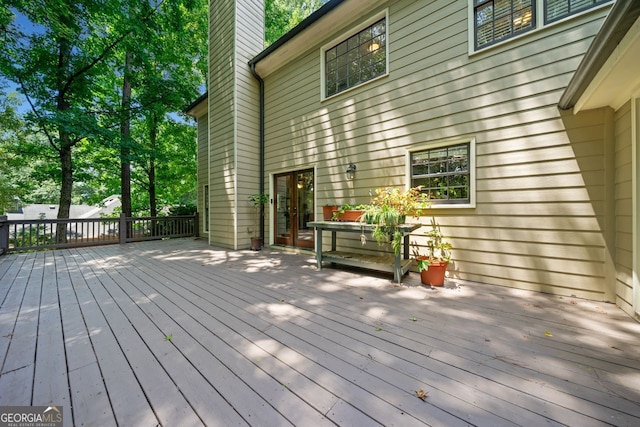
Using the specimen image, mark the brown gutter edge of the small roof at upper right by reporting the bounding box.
[558,0,640,110]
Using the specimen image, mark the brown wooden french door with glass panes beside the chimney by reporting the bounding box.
[273,169,315,248]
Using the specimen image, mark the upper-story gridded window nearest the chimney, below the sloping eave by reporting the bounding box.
[324,17,387,97]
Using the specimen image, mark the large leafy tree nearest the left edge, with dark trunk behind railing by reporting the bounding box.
[0,0,148,241]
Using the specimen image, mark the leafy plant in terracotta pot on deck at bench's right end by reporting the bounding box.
[415,218,451,286]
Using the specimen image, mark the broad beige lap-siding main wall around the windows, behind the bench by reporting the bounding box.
[266,0,607,299]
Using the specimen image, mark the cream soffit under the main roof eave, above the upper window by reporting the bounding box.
[255,0,386,77]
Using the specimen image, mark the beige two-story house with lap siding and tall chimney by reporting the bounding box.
[188,0,640,316]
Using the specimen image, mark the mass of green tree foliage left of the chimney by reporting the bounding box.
[0,0,207,211]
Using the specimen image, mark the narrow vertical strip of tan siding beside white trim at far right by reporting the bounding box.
[615,102,633,315]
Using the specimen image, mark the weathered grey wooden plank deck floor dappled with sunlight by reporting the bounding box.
[0,239,640,426]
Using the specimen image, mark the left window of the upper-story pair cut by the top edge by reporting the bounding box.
[473,0,535,48]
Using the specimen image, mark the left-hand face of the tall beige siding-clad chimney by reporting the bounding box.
[209,1,236,248]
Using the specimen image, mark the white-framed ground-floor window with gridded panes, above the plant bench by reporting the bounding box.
[410,141,475,206]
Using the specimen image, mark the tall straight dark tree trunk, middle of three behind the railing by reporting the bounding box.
[120,51,131,227]
